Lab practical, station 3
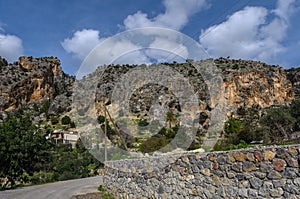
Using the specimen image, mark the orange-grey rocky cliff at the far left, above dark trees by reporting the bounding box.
[0,57,74,111]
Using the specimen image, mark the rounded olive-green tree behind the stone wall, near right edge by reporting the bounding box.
[260,107,296,143]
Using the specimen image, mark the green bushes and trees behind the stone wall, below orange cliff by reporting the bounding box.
[214,99,300,150]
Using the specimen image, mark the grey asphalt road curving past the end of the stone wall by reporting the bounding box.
[0,176,102,199]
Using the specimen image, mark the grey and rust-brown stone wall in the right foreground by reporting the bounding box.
[104,145,300,199]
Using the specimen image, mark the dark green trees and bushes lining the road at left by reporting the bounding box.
[0,110,101,189]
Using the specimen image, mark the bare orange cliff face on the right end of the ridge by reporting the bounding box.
[215,59,294,116]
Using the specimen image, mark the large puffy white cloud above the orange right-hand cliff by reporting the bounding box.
[200,7,267,58]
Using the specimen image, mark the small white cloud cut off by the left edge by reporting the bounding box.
[0,34,23,62]
